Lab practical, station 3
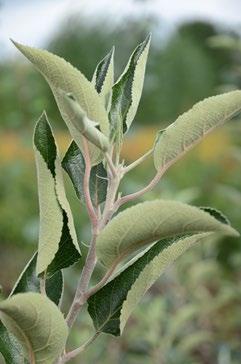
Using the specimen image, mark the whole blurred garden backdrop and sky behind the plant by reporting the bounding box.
[0,0,241,364]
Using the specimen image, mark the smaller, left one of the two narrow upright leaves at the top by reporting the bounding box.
[92,47,115,110]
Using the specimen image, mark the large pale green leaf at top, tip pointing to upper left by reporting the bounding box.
[13,42,109,164]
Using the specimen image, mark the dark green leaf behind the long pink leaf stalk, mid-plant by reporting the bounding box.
[62,141,108,206]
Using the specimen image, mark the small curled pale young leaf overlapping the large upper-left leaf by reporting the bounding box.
[59,90,109,152]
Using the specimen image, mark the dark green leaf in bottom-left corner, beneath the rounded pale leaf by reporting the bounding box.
[0,322,26,364]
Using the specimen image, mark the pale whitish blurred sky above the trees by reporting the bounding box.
[0,0,241,56]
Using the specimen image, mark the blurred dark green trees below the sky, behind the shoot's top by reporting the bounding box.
[0,16,234,129]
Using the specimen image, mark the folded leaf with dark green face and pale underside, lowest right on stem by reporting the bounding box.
[88,233,212,336]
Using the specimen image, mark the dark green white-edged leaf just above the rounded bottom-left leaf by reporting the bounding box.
[10,253,64,305]
